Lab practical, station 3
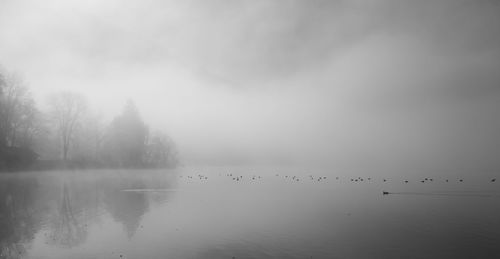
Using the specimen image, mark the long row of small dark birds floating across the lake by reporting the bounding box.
[179,173,496,184]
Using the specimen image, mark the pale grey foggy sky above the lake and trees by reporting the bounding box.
[0,0,500,172]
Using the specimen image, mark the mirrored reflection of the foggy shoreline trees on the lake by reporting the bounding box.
[0,173,176,259]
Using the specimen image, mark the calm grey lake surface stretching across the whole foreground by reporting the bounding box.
[0,168,500,258]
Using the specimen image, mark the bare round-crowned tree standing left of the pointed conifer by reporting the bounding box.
[50,92,87,161]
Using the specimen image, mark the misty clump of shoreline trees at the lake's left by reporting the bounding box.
[0,69,178,171]
